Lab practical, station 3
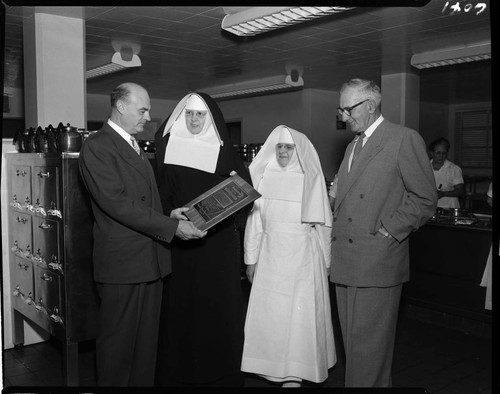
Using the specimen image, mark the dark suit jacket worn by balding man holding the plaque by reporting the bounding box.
[79,123,178,284]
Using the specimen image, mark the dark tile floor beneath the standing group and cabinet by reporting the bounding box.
[3,282,492,394]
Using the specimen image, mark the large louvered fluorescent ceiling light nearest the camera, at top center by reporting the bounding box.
[221,7,353,36]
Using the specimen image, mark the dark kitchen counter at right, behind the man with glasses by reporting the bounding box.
[404,215,492,322]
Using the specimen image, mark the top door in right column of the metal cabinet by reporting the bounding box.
[32,166,61,212]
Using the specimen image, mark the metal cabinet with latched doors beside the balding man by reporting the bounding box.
[6,153,98,386]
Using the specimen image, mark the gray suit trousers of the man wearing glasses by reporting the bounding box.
[335,284,403,387]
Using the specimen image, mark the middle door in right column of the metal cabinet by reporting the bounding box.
[33,216,62,266]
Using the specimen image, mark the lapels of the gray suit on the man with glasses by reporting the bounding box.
[335,120,385,209]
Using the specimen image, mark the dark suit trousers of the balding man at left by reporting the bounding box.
[96,279,162,386]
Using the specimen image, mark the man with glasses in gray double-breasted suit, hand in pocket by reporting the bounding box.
[330,79,437,387]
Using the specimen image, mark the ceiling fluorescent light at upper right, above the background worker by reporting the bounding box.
[411,43,491,69]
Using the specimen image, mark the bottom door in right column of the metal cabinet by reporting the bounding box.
[34,265,62,315]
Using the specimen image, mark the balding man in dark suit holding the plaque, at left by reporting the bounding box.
[79,83,206,386]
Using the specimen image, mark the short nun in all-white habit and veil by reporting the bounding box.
[241,125,336,387]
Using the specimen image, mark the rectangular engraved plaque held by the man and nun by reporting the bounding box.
[184,174,260,231]
